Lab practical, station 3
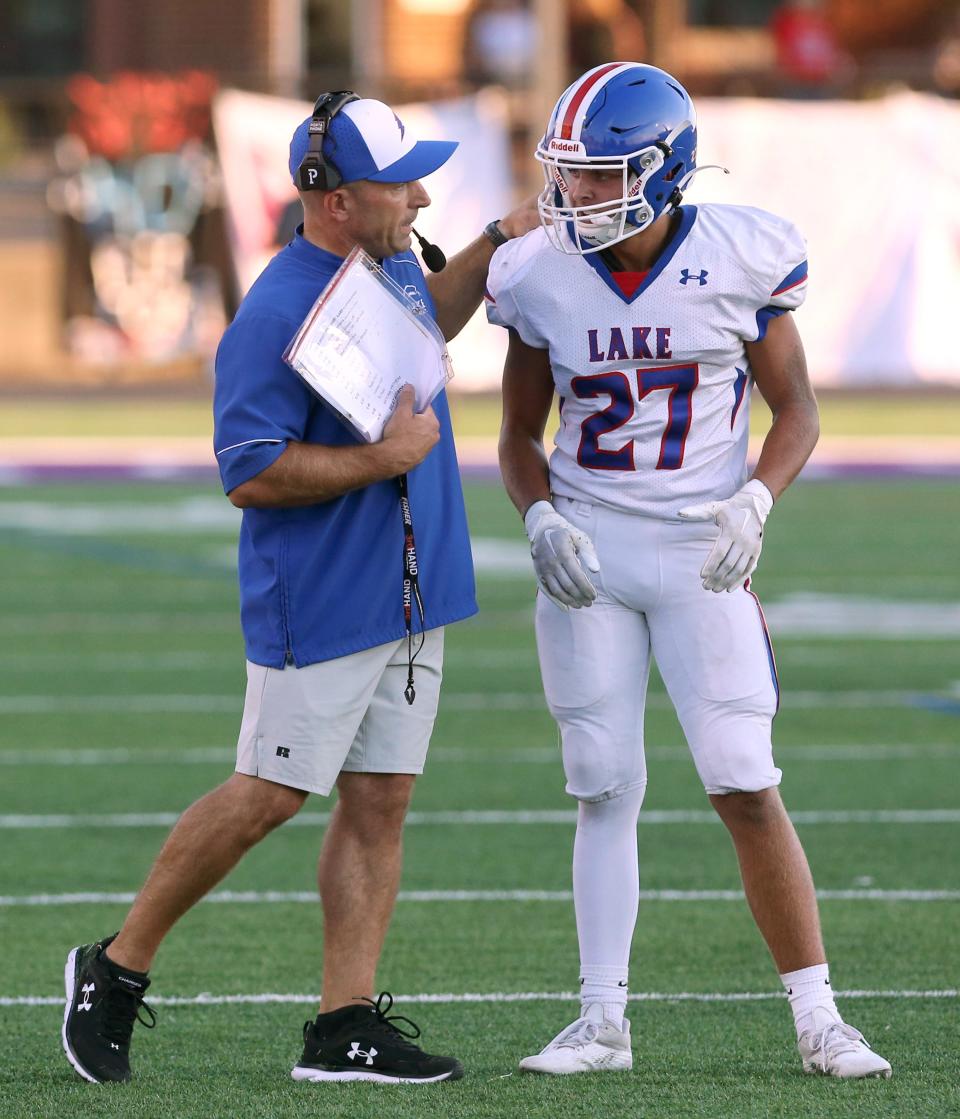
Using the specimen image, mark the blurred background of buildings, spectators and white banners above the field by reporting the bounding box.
[0,0,960,396]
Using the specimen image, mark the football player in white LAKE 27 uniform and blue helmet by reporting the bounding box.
[487,63,891,1078]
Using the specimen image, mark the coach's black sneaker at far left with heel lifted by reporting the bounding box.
[60,937,157,1084]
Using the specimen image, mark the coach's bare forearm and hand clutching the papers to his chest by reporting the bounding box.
[228,385,440,509]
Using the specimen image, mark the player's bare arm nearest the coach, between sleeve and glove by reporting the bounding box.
[500,330,554,517]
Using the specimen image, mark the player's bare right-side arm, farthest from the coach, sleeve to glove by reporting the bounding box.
[746,312,820,499]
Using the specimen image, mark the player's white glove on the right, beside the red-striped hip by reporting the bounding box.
[678,478,773,592]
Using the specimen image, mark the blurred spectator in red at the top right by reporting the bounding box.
[770,0,853,97]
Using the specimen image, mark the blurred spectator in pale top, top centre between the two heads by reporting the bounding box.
[463,0,537,88]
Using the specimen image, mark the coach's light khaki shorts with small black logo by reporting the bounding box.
[236,628,443,797]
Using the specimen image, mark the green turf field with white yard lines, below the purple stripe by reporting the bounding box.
[0,481,960,1119]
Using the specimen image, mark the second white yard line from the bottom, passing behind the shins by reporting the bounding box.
[0,888,960,909]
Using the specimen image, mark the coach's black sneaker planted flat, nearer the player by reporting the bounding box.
[290,991,463,1084]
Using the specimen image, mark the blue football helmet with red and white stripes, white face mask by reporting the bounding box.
[536,63,697,255]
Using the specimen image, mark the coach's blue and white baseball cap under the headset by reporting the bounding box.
[289,97,458,182]
